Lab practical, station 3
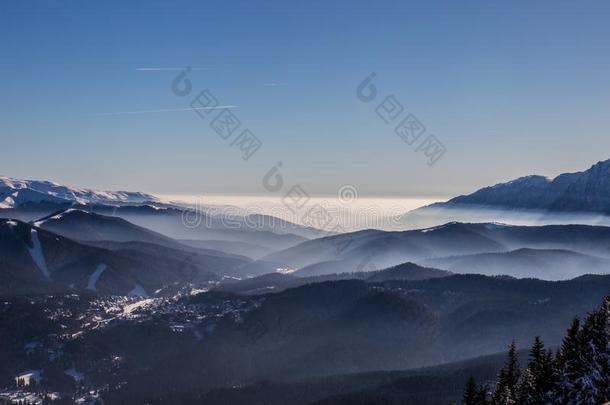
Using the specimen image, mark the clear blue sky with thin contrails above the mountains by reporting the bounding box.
[0,1,610,196]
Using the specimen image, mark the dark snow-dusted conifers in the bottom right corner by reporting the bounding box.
[462,296,610,405]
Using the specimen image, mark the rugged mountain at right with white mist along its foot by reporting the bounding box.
[398,160,610,229]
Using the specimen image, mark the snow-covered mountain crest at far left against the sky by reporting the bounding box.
[0,176,159,208]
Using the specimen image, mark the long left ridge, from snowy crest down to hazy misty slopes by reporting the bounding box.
[0,177,327,252]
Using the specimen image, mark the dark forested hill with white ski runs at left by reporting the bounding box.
[0,219,258,295]
